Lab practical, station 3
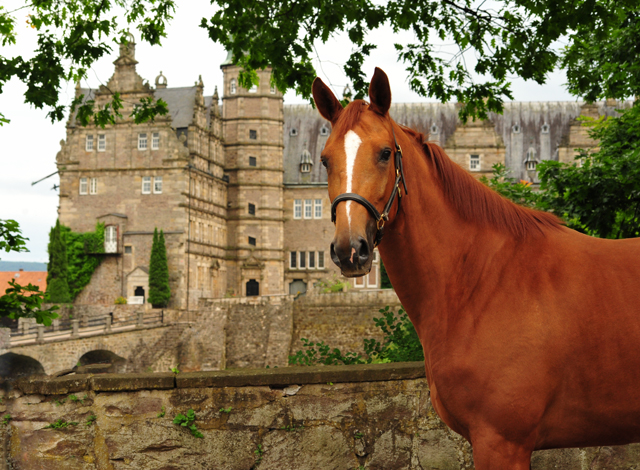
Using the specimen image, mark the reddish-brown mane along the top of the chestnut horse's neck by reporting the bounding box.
[401,126,563,238]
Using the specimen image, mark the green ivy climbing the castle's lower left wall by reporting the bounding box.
[60,222,104,301]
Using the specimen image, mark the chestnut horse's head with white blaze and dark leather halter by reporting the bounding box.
[313,68,406,277]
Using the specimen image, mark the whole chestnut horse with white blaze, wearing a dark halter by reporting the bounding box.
[313,69,640,470]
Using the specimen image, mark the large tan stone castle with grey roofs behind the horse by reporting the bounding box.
[57,38,619,309]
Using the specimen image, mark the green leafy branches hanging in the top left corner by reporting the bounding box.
[0,0,175,126]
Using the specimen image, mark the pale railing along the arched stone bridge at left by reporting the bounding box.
[11,310,165,346]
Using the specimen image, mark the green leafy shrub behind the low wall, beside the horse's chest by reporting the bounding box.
[289,306,424,366]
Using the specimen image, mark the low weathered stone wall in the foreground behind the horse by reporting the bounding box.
[0,363,640,470]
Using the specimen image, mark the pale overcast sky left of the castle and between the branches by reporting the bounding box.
[0,0,575,261]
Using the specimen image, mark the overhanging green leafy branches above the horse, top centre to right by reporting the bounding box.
[201,0,638,119]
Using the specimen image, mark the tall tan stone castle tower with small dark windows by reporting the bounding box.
[221,54,284,296]
